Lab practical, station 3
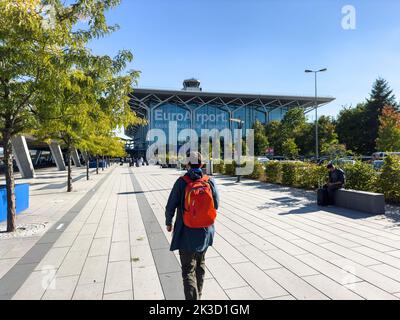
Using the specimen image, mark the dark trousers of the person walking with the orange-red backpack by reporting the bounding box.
[179,250,207,300]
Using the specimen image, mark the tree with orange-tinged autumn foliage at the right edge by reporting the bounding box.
[376,106,400,151]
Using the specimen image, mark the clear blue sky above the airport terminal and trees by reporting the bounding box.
[91,0,400,119]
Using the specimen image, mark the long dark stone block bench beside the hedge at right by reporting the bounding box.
[334,189,385,214]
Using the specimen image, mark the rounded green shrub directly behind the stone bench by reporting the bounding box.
[343,161,378,192]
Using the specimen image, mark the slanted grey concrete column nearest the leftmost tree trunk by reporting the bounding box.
[11,136,35,179]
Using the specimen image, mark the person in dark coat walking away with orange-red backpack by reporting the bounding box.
[165,152,219,300]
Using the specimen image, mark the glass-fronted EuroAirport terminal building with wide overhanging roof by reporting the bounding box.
[126,79,334,155]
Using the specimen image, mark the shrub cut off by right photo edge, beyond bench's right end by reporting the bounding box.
[379,156,400,203]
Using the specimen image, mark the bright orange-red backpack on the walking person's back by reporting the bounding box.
[183,175,217,228]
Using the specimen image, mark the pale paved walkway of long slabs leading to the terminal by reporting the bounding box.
[0,166,400,299]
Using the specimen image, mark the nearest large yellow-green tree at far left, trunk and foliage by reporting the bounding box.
[0,0,132,232]
